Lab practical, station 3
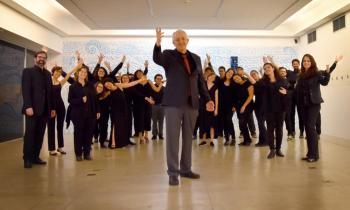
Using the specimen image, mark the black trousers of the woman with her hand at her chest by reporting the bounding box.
[72,118,96,156]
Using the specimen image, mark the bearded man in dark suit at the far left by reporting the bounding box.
[22,51,56,168]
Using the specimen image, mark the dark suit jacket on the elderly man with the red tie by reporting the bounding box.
[153,45,211,109]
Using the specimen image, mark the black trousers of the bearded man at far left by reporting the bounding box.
[23,115,48,161]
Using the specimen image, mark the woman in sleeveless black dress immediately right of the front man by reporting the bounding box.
[199,73,219,147]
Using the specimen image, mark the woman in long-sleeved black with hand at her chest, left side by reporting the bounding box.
[68,66,100,161]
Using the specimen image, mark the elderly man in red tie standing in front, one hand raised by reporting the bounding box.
[153,28,214,185]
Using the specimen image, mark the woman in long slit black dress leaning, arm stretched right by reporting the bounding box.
[104,77,147,149]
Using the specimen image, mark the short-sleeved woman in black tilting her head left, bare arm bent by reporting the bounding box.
[233,74,254,146]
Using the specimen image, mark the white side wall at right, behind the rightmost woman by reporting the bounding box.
[298,12,350,139]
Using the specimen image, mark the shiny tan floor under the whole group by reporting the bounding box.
[0,136,350,210]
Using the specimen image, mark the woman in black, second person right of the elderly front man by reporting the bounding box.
[219,68,236,146]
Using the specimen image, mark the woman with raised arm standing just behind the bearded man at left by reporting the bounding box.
[47,63,78,156]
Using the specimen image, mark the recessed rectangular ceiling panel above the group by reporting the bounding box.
[57,0,311,30]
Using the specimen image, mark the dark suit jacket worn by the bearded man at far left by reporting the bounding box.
[22,66,55,116]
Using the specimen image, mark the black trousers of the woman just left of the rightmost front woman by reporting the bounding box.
[265,112,285,150]
